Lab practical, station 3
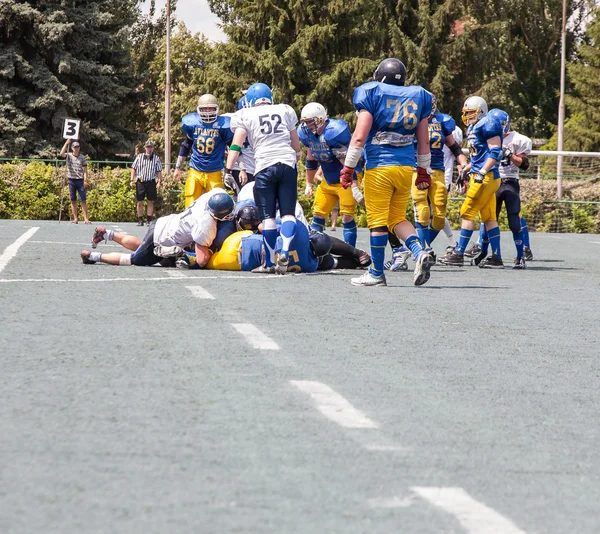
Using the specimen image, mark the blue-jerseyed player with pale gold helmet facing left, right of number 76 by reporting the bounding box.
[440,96,504,269]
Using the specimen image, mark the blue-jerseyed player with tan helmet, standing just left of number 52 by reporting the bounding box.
[174,94,233,208]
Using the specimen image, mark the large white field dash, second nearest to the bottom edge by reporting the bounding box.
[290,380,379,428]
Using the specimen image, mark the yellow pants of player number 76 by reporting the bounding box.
[364,166,413,232]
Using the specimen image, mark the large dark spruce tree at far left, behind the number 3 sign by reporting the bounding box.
[0,0,139,157]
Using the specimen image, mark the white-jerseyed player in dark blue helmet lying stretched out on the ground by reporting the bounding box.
[81,188,234,267]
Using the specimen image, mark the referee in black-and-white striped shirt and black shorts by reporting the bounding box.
[131,139,162,226]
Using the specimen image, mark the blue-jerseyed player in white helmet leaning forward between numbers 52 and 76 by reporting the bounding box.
[298,102,363,246]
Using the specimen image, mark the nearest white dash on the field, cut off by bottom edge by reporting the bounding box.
[411,487,525,534]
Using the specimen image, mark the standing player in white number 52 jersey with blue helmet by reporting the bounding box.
[224,83,302,274]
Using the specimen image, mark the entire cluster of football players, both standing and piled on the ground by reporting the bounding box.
[81,58,532,286]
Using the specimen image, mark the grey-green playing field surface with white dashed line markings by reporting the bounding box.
[0,221,600,534]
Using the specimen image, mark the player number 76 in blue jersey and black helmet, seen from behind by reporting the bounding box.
[340,58,434,286]
